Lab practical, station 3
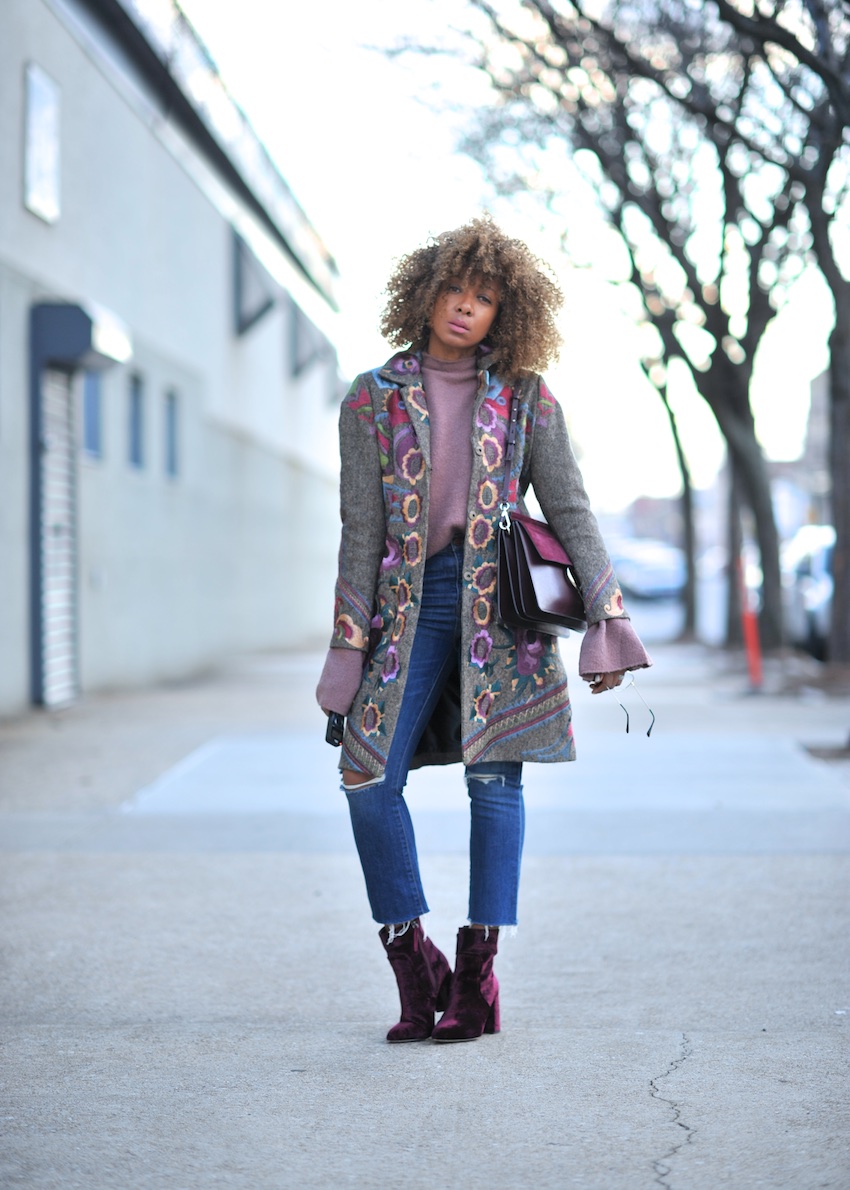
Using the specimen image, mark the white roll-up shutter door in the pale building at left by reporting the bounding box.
[35,370,79,707]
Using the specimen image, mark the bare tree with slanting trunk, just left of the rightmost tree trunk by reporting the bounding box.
[450,0,807,645]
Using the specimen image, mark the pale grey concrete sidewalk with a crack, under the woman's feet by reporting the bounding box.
[0,640,850,1190]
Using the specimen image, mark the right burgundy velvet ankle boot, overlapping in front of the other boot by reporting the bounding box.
[431,926,501,1041]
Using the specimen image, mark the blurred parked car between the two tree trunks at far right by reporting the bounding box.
[782,525,836,660]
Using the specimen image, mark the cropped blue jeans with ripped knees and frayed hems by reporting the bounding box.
[343,543,525,926]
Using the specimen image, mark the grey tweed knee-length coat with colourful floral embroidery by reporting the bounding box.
[331,352,625,776]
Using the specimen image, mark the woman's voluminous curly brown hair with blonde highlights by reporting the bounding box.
[381,215,563,381]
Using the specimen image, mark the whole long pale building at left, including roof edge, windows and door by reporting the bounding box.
[0,0,339,715]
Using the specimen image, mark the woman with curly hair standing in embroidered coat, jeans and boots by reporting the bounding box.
[317,218,651,1041]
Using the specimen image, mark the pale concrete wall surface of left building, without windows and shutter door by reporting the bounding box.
[0,0,339,714]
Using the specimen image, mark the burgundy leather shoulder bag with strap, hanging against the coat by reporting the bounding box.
[496,396,587,637]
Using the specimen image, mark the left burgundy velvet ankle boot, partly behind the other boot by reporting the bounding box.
[379,921,451,1041]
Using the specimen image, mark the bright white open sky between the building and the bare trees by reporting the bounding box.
[181,0,832,512]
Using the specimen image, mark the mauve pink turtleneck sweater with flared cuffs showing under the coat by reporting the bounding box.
[315,353,650,715]
